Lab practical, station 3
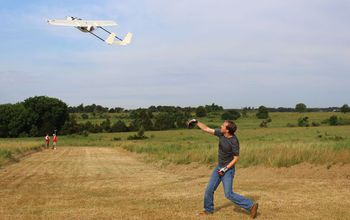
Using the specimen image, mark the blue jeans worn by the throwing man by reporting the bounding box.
[204,166,253,213]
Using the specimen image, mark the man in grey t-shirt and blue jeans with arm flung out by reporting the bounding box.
[188,119,258,218]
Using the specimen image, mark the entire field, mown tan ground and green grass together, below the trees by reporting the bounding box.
[0,113,350,219]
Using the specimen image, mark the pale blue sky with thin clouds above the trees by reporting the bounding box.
[0,0,350,108]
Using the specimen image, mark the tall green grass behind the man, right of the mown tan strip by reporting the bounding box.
[121,126,350,167]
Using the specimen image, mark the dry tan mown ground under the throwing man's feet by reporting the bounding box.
[0,147,350,219]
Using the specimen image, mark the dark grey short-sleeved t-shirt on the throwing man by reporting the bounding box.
[214,128,239,167]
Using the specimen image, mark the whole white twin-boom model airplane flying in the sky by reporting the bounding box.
[47,17,132,45]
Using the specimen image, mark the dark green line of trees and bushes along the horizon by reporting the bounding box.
[0,96,350,137]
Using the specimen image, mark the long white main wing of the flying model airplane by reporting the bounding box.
[47,19,117,27]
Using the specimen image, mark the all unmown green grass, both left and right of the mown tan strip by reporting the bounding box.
[0,113,350,167]
